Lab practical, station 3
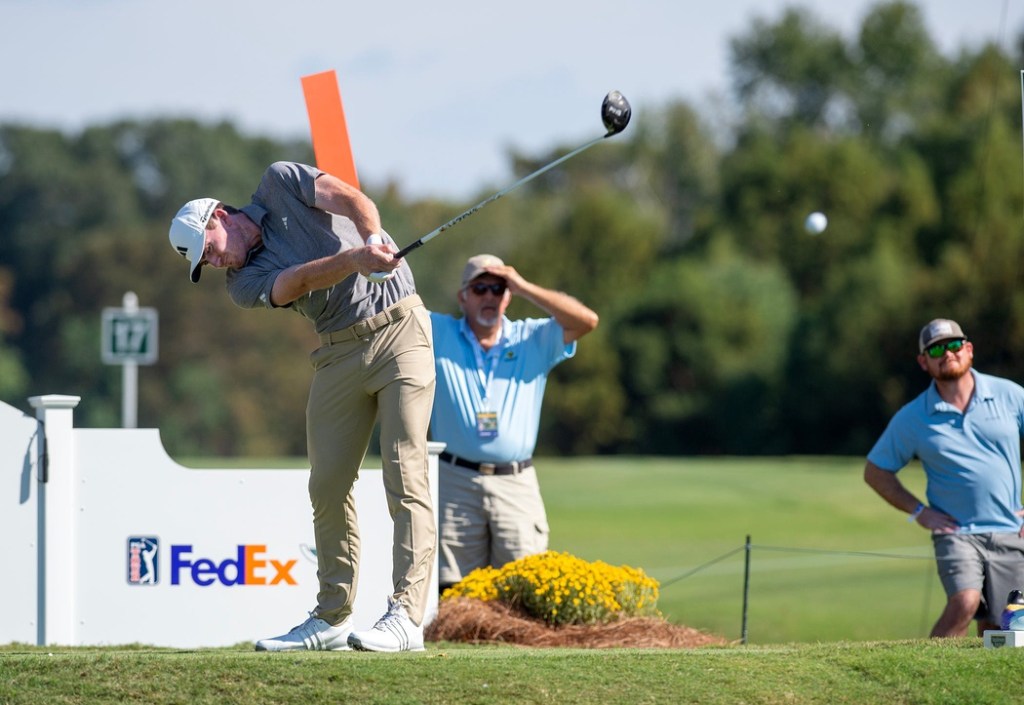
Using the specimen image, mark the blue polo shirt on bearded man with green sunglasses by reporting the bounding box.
[867,370,1024,534]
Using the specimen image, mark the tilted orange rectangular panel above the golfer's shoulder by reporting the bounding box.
[302,70,359,189]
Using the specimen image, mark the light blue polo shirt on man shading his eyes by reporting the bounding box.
[430,313,577,463]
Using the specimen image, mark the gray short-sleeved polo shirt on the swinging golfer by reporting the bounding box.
[226,162,416,333]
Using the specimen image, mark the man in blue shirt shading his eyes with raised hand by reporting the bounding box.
[430,254,597,590]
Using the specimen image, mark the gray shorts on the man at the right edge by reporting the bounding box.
[932,533,1024,624]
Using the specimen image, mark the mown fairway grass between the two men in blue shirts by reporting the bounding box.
[538,457,945,644]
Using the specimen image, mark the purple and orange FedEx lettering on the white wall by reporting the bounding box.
[171,544,298,587]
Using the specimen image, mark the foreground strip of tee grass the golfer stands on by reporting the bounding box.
[0,639,1021,705]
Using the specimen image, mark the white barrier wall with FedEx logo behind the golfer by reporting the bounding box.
[0,397,443,648]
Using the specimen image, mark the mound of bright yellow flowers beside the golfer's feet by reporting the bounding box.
[441,551,660,624]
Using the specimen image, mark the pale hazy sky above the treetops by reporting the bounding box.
[0,0,1024,199]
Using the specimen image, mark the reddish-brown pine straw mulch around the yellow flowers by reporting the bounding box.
[424,597,729,649]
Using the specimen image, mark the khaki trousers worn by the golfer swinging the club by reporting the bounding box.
[306,297,436,624]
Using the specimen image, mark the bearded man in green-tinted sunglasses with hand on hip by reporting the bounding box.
[864,319,1024,636]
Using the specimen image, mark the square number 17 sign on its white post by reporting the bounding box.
[100,291,159,428]
